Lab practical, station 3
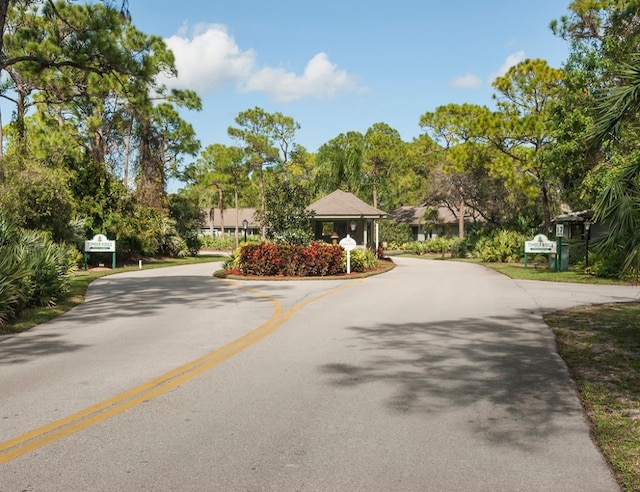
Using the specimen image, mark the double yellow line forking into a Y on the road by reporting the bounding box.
[0,279,364,464]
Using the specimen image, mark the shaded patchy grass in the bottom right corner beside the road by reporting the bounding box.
[545,303,640,492]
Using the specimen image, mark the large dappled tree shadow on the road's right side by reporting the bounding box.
[320,311,583,448]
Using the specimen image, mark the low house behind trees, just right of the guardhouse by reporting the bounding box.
[389,206,482,241]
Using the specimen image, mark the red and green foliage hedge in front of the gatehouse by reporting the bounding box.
[239,242,343,277]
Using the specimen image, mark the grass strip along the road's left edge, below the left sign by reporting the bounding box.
[0,255,225,334]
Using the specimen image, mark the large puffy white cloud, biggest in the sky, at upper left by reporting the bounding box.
[162,25,364,101]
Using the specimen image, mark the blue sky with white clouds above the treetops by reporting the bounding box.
[129,0,569,156]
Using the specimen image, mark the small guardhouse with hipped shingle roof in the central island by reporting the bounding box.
[307,190,387,248]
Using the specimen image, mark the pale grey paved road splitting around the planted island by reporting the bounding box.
[0,258,640,492]
